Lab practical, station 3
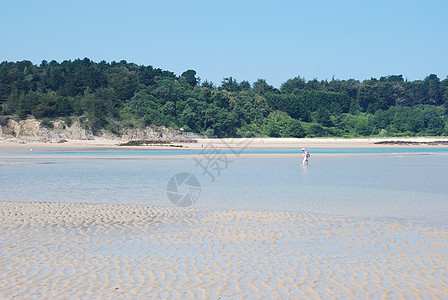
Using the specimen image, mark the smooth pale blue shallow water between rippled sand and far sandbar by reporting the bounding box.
[0,148,448,224]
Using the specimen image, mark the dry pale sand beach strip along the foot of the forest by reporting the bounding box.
[0,137,448,153]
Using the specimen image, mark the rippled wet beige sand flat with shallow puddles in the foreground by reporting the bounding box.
[0,202,448,299]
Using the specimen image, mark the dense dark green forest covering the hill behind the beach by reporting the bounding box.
[0,58,448,137]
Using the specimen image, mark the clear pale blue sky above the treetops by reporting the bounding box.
[0,0,448,87]
